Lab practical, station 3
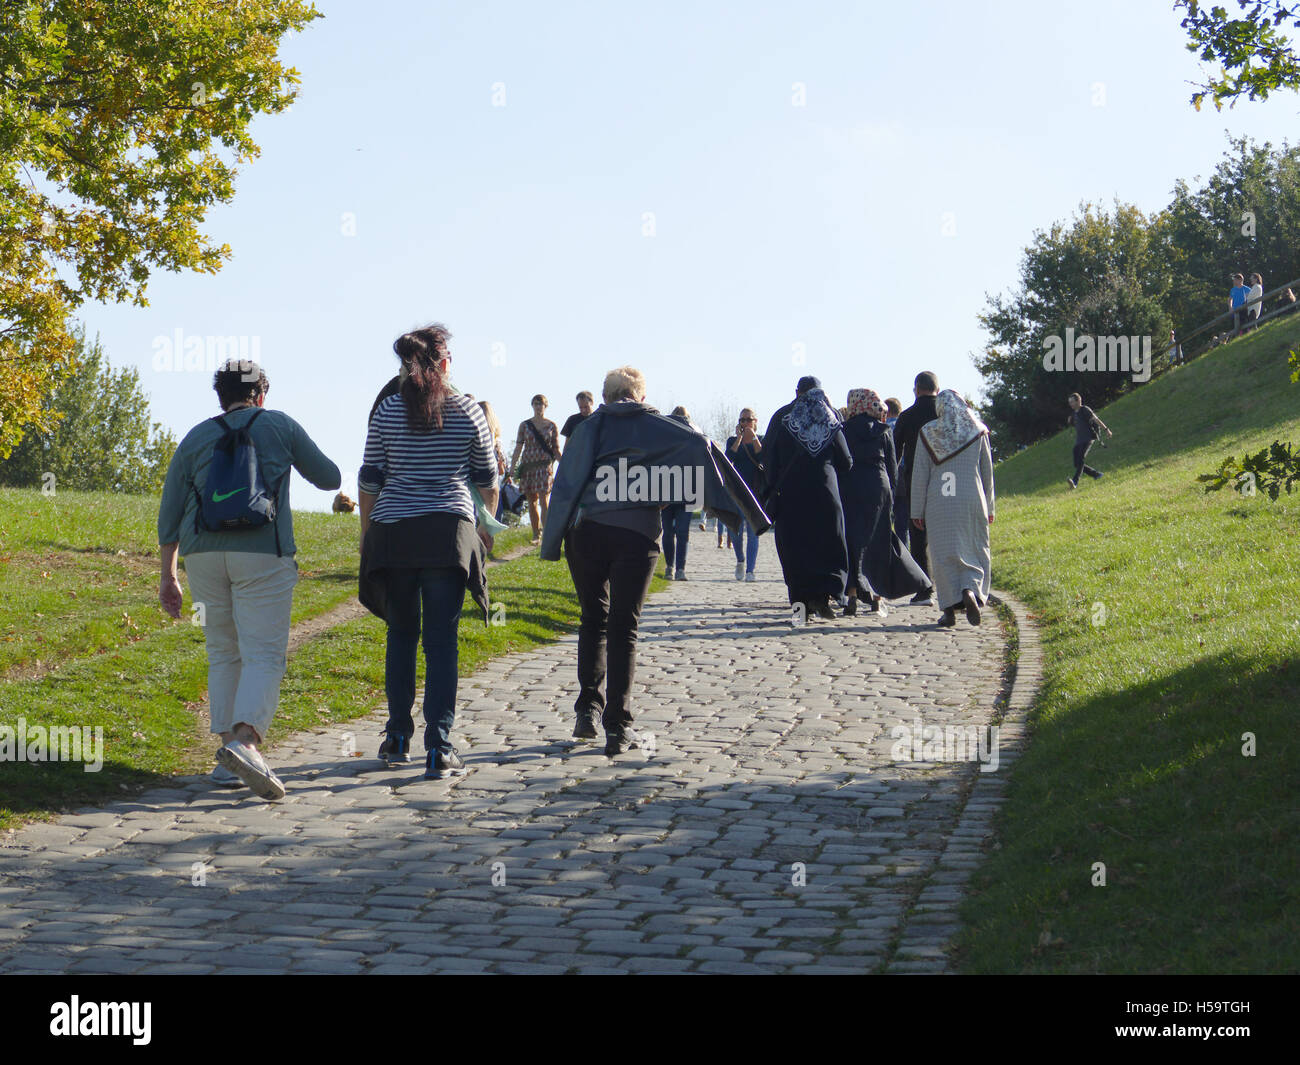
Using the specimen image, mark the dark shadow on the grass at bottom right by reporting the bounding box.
[962,642,1300,973]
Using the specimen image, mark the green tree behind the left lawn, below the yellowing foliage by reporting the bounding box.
[0,330,176,492]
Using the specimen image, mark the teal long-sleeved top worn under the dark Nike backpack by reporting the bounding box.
[159,407,343,557]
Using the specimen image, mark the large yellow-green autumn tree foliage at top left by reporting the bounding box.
[0,0,320,456]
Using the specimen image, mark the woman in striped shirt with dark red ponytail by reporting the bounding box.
[358,324,497,780]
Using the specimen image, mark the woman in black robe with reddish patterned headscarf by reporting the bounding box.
[840,389,931,616]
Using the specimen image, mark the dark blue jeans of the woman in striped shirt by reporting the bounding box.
[384,567,465,752]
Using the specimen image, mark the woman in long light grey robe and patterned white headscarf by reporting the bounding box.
[911,389,993,628]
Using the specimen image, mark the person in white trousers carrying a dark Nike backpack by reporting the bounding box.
[159,360,342,798]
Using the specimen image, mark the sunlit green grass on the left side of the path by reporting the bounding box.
[0,490,605,828]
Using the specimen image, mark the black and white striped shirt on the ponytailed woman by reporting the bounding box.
[356,395,497,523]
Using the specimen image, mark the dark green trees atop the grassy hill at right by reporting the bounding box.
[975,138,1300,455]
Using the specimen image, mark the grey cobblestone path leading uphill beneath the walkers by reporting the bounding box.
[0,531,1011,973]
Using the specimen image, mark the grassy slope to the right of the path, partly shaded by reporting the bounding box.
[961,312,1300,973]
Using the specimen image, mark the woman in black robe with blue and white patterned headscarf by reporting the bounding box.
[763,377,853,618]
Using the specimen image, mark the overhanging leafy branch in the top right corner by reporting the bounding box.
[1174,0,1300,111]
